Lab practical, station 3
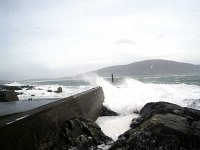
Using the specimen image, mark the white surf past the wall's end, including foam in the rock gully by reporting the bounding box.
[89,75,200,140]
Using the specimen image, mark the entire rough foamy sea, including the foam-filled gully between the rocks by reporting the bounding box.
[1,74,200,144]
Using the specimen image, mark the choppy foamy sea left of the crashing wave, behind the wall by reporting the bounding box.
[6,79,91,100]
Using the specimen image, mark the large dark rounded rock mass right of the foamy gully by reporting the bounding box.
[110,102,200,150]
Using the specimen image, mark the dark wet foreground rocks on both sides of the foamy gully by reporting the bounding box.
[41,102,200,150]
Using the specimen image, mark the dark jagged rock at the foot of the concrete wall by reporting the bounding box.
[43,118,112,150]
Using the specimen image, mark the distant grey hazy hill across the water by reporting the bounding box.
[94,59,200,76]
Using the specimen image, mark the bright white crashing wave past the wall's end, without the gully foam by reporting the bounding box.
[85,76,200,115]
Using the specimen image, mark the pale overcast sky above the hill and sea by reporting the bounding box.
[0,0,200,80]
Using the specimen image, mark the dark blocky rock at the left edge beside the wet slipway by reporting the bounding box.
[0,90,19,102]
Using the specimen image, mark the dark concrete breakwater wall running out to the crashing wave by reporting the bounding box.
[0,87,104,150]
